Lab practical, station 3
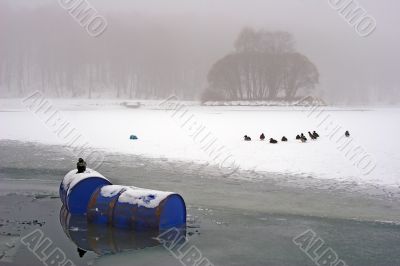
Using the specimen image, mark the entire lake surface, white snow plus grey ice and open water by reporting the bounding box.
[0,99,400,265]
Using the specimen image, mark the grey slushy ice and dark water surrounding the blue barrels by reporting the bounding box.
[0,141,400,265]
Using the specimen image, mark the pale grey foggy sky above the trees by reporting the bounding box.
[0,0,400,102]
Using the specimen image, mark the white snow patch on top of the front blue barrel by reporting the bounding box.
[118,187,175,208]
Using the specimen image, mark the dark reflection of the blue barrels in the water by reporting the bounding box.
[60,206,186,257]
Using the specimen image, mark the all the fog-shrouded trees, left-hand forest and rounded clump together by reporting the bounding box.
[0,7,318,103]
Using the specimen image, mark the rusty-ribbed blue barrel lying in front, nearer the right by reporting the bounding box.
[87,185,186,231]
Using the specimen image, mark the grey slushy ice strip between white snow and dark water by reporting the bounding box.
[0,141,400,222]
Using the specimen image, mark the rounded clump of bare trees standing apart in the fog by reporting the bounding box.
[202,28,319,101]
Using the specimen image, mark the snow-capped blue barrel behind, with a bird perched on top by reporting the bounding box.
[59,168,111,214]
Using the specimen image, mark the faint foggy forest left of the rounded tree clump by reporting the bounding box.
[0,2,211,99]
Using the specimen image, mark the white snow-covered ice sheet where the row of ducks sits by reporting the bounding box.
[0,99,400,187]
